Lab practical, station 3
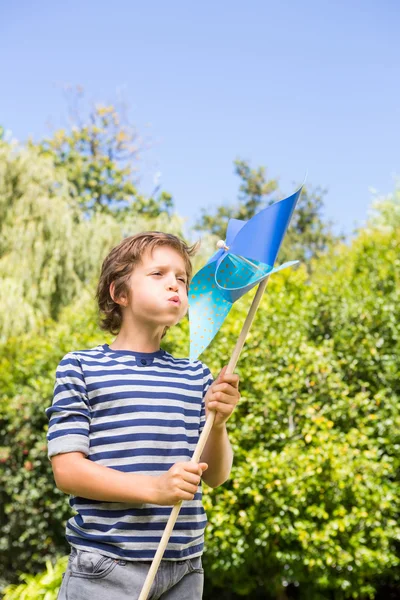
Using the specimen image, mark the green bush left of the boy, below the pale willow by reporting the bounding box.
[0,294,98,577]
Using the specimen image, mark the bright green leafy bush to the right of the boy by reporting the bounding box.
[200,225,400,599]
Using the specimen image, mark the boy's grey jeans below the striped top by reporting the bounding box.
[57,548,204,600]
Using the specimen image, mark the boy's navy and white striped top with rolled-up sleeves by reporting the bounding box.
[46,344,213,560]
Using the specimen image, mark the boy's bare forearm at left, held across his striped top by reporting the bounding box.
[52,453,159,504]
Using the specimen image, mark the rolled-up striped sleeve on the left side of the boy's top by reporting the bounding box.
[46,353,90,459]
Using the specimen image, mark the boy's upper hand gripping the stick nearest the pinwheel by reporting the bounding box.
[204,365,240,427]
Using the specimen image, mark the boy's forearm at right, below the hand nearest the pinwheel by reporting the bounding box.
[200,424,233,487]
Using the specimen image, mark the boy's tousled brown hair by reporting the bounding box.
[96,231,200,337]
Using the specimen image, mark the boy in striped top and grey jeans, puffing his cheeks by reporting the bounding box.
[46,231,240,600]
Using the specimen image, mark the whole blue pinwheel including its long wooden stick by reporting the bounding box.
[139,186,303,600]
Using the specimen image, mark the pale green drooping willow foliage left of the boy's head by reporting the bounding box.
[0,141,183,341]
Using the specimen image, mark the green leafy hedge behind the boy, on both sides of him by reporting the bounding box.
[0,231,400,600]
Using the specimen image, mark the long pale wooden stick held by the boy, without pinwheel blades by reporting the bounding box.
[138,277,269,600]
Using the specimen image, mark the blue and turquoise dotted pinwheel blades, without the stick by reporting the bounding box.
[189,188,302,361]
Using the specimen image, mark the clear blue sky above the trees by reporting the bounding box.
[0,0,400,239]
